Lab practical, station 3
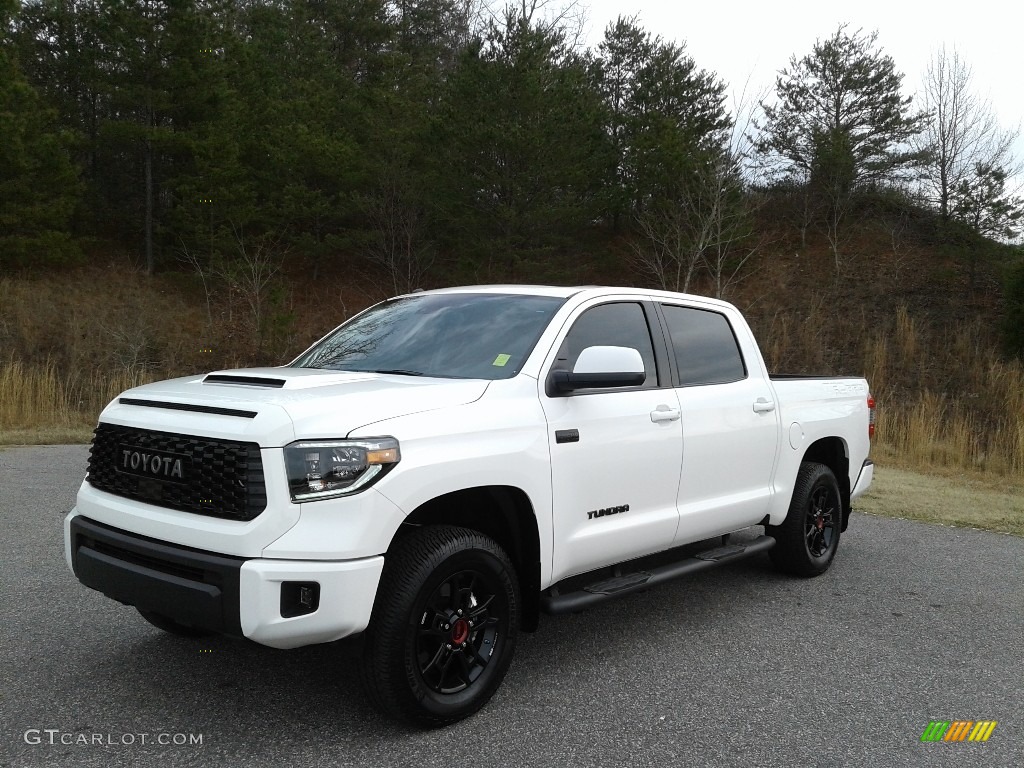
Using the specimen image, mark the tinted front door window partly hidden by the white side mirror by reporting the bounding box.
[552,302,657,388]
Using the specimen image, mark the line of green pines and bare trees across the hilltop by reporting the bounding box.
[0,0,1024,295]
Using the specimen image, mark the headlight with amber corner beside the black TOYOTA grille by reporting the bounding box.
[285,437,400,502]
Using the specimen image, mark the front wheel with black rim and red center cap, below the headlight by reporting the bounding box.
[361,525,519,727]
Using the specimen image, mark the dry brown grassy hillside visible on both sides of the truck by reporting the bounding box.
[0,259,1024,477]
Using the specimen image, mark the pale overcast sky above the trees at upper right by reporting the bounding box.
[580,0,1024,161]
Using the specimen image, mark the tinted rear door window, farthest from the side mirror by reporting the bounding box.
[662,304,746,387]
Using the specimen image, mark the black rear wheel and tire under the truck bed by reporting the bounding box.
[767,462,843,577]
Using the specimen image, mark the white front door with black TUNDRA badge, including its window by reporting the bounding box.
[541,298,682,581]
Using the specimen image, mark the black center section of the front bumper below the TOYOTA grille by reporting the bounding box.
[71,515,246,637]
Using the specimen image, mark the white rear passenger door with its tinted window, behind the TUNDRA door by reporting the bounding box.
[659,302,779,545]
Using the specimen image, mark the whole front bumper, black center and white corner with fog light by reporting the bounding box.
[65,510,384,648]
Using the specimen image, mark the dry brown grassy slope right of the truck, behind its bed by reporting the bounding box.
[748,270,1024,477]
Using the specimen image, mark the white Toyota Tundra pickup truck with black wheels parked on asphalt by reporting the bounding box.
[65,286,873,725]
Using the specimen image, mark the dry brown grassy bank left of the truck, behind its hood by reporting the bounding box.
[0,263,378,444]
